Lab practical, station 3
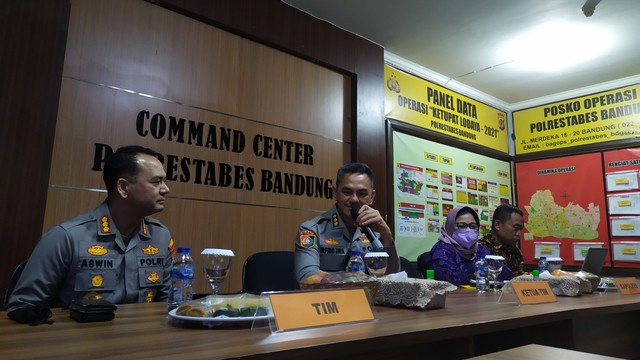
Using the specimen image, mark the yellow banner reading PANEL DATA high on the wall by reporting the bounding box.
[384,65,509,153]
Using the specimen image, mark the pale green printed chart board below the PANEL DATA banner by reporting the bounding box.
[393,131,512,261]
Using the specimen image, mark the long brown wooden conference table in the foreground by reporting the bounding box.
[0,289,640,360]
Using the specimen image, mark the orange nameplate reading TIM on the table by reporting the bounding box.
[269,288,376,331]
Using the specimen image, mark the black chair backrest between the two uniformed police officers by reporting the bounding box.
[242,251,298,294]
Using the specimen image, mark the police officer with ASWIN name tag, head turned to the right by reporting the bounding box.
[8,146,174,315]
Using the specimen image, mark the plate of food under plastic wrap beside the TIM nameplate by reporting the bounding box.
[169,294,273,327]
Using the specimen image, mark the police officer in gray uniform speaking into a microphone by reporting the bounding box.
[294,163,400,282]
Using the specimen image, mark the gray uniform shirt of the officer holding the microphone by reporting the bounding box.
[294,205,380,282]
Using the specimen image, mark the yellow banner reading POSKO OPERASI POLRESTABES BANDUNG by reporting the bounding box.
[513,85,640,154]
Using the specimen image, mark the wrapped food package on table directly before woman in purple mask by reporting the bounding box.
[374,277,458,309]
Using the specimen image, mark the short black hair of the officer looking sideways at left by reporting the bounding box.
[102,145,158,194]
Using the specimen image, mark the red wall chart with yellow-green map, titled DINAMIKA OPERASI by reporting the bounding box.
[516,153,609,265]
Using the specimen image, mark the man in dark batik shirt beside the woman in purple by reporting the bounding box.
[478,204,524,280]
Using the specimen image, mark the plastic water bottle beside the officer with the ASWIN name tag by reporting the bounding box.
[167,247,195,310]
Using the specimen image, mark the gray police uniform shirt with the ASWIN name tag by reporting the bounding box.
[8,202,173,311]
